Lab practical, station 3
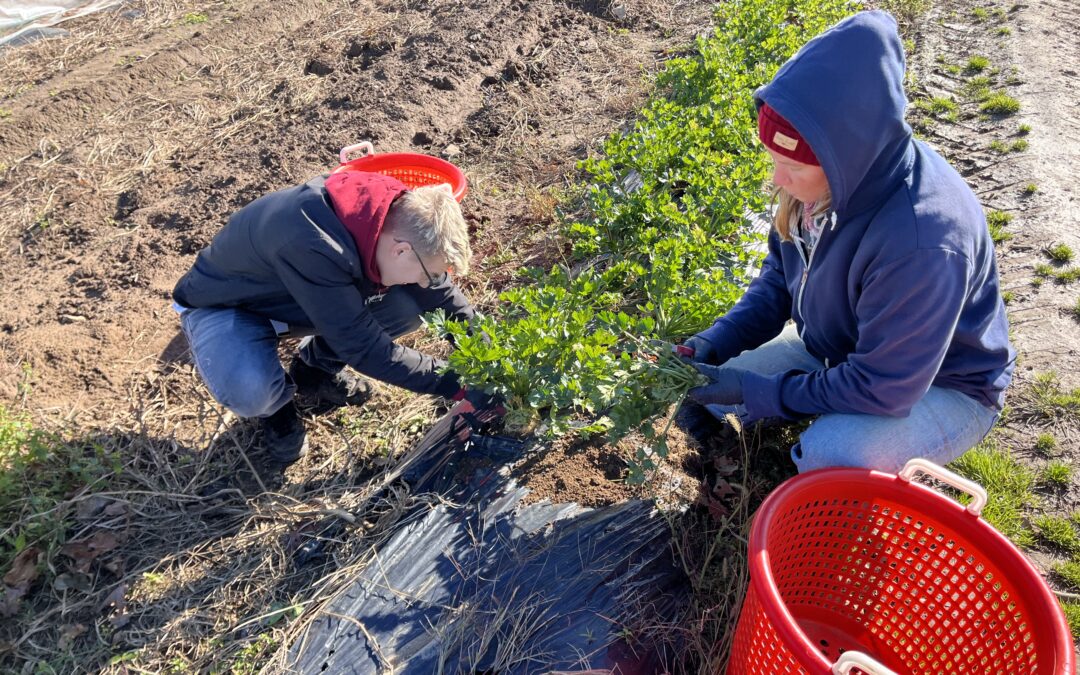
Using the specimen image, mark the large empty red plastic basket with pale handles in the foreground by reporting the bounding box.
[727,459,1075,675]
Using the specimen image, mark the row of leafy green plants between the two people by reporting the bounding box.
[431,0,855,481]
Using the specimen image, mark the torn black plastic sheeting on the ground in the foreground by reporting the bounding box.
[289,406,687,675]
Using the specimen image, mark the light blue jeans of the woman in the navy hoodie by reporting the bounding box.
[706,324,998,473]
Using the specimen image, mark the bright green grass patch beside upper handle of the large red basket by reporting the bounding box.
[949,438,1036,546]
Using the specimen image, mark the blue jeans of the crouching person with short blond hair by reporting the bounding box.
[180,286,432,417]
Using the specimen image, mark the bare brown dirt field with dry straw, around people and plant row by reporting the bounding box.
[0,0,1080,673]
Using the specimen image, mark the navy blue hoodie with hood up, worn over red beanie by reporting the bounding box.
[701,11,1015,419]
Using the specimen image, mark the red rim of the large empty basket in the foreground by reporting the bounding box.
[744,468,1076,675]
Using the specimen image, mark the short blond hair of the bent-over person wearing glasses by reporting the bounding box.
[387,185,472,274]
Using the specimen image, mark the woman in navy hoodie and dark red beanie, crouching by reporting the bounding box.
[687,11,1015,471]
